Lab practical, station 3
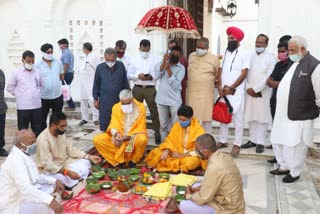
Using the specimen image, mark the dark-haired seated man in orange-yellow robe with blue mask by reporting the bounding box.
[145,105,206,172]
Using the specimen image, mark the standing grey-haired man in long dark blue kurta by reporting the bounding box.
[92,48,129,132]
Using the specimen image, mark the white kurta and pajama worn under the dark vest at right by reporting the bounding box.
[270,62,320,177]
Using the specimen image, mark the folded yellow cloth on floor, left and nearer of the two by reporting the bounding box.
[143,182,172,200]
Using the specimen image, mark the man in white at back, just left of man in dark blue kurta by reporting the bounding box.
[79,42,101,125]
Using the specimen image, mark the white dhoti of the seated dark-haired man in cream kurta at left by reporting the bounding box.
[48,159,91,187]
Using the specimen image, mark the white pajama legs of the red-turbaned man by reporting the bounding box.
[219,95,244,146]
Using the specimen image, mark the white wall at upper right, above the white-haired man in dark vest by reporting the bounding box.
[258,0,320,59]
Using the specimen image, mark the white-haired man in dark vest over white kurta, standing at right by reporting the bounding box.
[270,36,320,183]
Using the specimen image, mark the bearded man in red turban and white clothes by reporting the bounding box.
[217,27,250,156]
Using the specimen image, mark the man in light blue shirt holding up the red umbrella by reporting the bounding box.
[156,46,185,141]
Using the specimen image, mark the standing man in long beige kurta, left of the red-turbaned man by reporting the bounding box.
[187,37,219,133]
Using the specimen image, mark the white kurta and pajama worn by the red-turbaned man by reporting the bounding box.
[219,47,250,146]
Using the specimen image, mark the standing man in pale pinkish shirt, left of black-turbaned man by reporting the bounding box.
[7,51,42,136]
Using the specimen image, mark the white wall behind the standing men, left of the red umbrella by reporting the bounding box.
[0,0,167,100]
